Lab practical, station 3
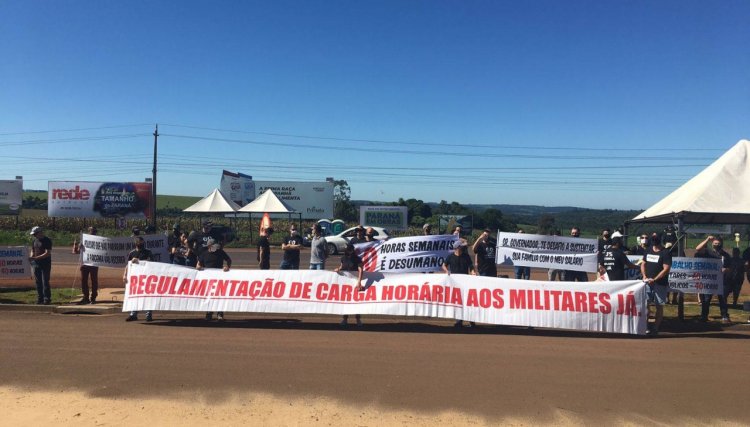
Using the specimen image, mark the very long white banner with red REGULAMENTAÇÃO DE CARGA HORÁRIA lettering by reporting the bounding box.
[123,262,647,334]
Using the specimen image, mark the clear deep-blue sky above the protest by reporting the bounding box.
[0,0,750,209]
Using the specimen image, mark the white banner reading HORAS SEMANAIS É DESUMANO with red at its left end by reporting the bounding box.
[354,234,458,273]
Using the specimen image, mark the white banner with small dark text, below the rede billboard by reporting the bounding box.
[79,234,169,268]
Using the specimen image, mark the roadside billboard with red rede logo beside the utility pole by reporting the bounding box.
[47,181,151,218]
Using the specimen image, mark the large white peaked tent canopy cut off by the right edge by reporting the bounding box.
[628,139,750,224]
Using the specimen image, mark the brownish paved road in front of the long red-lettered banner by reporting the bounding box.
[0,311,750,424]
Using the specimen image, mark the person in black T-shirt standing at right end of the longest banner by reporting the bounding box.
[641,233,672,335]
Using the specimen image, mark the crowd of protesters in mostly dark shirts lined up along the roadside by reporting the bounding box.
[22,221,750,334]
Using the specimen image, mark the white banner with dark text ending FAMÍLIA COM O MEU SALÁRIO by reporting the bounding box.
[497,232,598,272]
